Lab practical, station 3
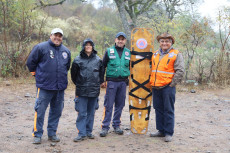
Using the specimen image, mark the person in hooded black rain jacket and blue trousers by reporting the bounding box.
[71,39,103,142]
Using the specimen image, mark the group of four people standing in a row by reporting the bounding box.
[27,28,184,144]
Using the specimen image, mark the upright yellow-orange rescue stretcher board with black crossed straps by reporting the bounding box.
[129,28,154,134]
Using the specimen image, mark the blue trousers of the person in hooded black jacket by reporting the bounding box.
[74,96,98,136]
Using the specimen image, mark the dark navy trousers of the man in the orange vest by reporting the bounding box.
[153,86,176,136]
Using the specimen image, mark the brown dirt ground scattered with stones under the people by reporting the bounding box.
[0,80,230,153]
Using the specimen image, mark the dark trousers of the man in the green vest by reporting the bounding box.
[102,81,126,130]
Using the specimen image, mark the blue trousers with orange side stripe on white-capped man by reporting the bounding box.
[33,88,64,137]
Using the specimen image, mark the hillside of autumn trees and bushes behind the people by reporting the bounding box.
[0,0,230,86]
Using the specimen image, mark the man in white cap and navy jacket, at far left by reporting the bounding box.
[27,28,71,144]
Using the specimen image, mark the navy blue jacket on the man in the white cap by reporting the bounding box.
[26,40,71,90]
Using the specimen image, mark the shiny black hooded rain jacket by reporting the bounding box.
[71,39,103,97]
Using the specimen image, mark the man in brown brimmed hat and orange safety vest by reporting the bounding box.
[150,33,184,142]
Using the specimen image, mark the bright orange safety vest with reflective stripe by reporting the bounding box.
[150,49,179,87]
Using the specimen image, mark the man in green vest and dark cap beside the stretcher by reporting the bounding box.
[100,32,130,137]
